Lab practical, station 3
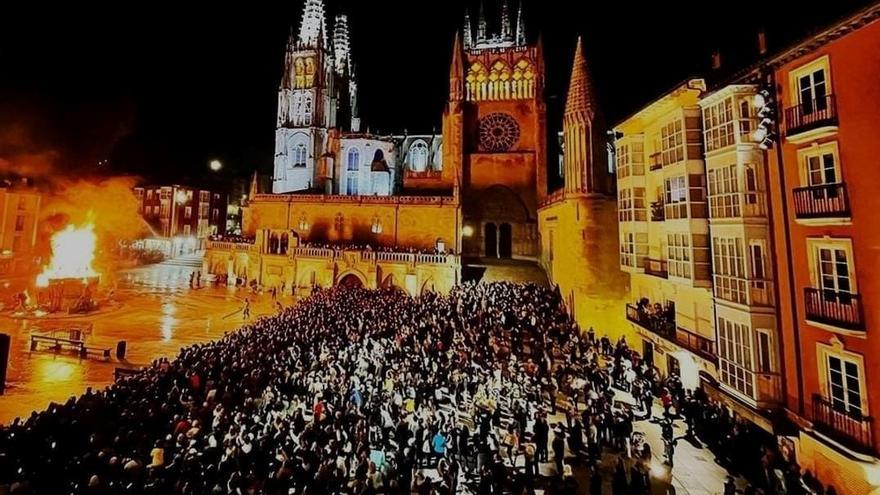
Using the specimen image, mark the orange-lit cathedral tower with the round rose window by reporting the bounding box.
[443,4,547,259]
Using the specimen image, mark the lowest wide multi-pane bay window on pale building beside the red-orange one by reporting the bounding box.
[718,318,755,397]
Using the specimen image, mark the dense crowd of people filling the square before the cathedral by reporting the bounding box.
[0,283,840,495]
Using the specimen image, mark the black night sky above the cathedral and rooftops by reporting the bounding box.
[0,0,868,185]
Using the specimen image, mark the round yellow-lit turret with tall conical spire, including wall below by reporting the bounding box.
[538,41,635,342]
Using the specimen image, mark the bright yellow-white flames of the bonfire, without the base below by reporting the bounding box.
[37,223,98,287]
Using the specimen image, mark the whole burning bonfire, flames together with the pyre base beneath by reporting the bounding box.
[37,223,99,312]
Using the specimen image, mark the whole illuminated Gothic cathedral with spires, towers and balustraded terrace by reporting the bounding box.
[209,0,617,326]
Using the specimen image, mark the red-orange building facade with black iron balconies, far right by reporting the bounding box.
[766,4,880,494]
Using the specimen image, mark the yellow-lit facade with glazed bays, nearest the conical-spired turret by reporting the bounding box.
[615,79,717,389]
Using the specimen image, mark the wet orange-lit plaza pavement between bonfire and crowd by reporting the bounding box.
[0,260,282,424]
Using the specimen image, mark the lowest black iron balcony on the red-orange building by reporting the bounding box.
[813,394,874,454]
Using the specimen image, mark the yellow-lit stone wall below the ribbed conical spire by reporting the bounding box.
[538,196,636,342]
